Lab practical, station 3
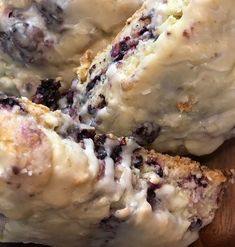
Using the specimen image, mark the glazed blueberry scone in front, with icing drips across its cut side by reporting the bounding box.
[0,97,226,247]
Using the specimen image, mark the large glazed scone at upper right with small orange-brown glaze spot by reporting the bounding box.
[78,0,235,155]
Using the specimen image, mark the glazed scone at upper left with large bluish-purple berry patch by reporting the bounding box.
[0,0,140,96]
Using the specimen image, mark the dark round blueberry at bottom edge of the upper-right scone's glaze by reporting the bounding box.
[132,122,161,146]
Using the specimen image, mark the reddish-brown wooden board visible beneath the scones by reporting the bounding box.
[192,139,235,247]
